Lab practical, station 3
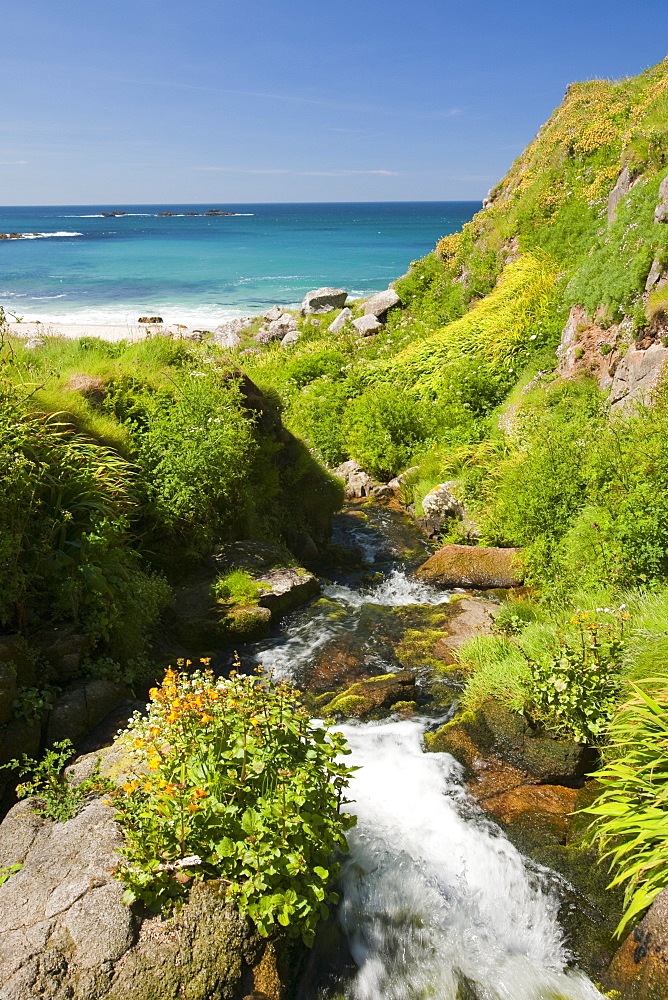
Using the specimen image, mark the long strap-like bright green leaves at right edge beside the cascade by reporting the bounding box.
[584,675,668,936]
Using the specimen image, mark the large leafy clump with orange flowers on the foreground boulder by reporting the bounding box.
[114,668,353,944]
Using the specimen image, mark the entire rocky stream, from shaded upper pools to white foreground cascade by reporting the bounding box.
[245,506,602,1000]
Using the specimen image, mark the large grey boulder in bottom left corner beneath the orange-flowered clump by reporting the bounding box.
[0,799,281,1000]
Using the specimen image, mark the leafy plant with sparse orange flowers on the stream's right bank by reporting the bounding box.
[528,609,628,743]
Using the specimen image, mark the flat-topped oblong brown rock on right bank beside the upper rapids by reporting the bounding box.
[416,545,524,590]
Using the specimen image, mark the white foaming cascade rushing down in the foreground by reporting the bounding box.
[337,720,601,1000]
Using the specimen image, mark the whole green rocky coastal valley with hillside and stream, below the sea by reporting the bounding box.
[0,60,668,1000]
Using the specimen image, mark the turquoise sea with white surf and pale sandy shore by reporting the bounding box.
[0,202,480,328]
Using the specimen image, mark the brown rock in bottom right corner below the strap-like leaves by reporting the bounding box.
[603,889,668,1000]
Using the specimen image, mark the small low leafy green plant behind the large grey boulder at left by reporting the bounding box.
[0,740,111,823]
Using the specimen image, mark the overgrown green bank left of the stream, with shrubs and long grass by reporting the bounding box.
[0,315,341,696]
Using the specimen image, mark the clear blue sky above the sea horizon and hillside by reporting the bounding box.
[0,0,668,205]
